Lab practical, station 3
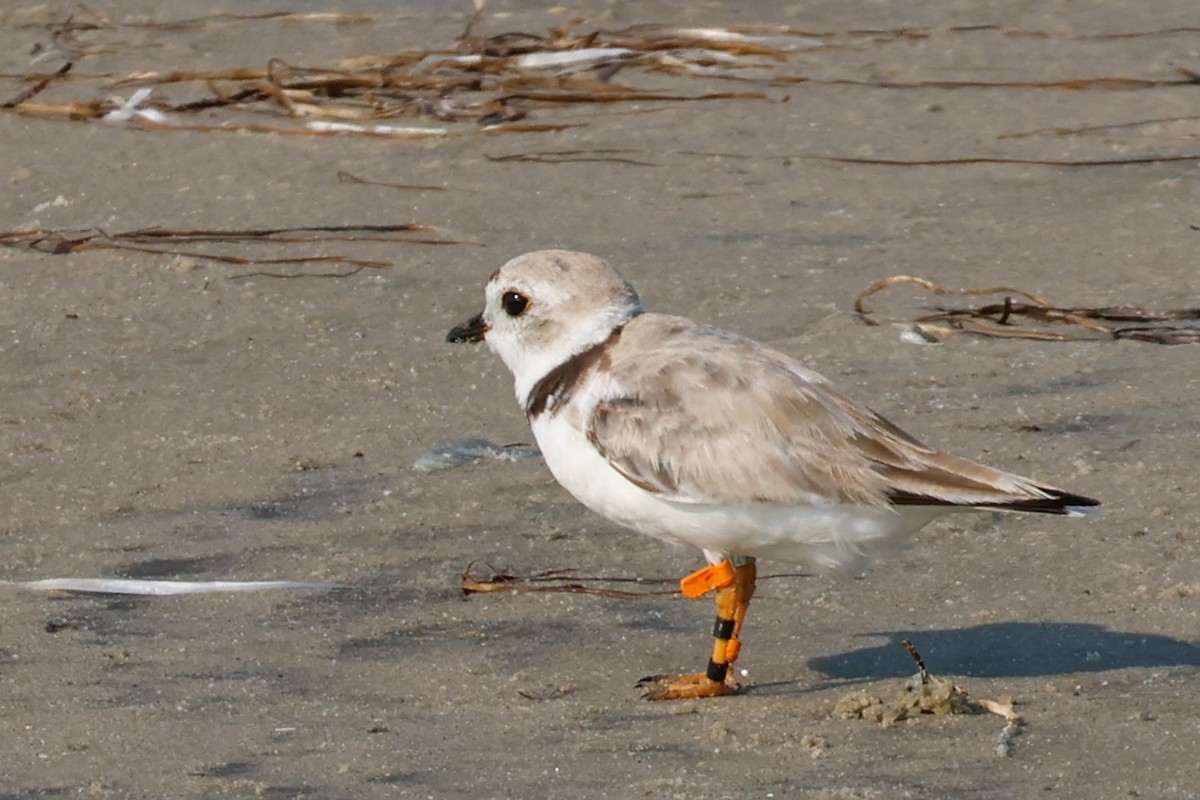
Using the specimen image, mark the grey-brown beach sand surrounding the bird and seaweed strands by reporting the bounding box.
[0,0,1200,800]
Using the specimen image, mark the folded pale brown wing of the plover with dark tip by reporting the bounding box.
[584,314,1096,512]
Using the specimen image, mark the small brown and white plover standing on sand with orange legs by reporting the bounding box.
[446,249,1099,699]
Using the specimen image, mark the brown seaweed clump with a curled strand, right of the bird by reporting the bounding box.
[854,275,1200,344]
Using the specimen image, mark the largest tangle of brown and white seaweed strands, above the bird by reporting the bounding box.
[0,7,768,140]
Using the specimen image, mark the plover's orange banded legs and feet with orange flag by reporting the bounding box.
[637,557,757,700]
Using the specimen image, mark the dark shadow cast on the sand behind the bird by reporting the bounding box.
[808,621,1200,681]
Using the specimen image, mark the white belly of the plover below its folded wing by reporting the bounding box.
[533,414,946,572]
